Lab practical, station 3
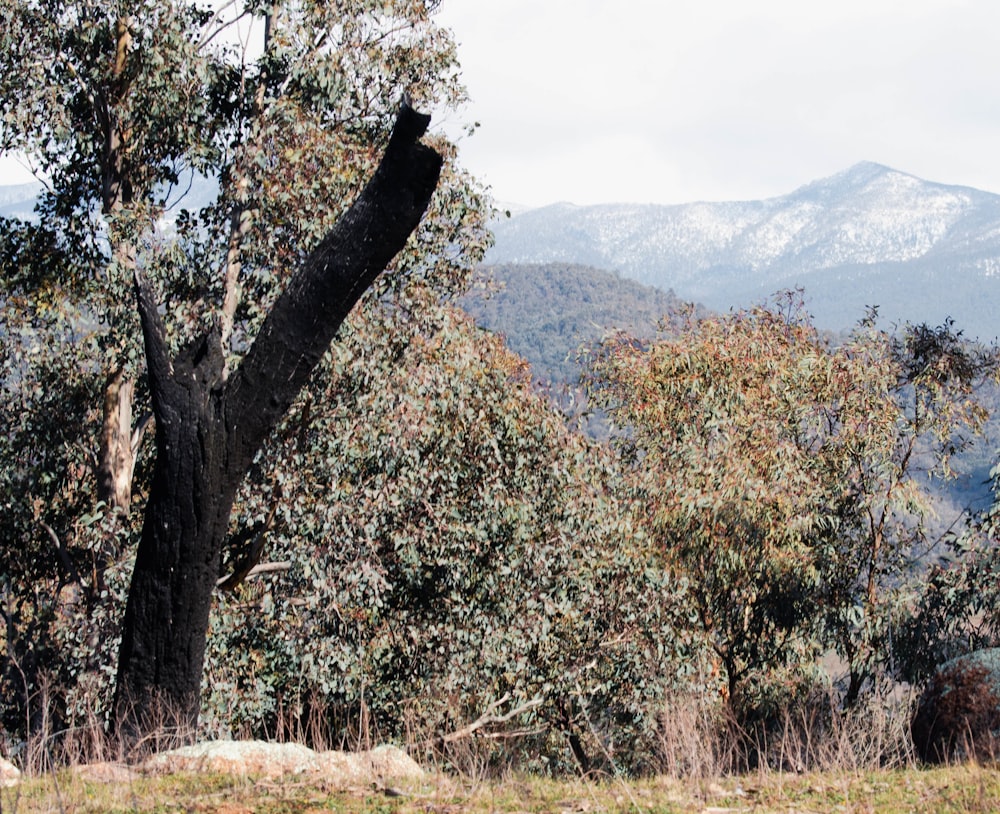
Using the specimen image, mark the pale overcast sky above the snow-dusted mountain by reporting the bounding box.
[438,0,1000,205]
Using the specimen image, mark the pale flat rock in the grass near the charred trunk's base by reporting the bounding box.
[142,741,423,786]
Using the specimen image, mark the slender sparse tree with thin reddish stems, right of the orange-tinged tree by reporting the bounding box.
[824,315,1000,704]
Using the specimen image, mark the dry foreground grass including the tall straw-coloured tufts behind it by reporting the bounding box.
[0,694,1000,814]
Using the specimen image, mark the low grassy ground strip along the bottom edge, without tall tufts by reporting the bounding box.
[0,765,1000,814]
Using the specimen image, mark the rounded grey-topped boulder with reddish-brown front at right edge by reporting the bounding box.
[910,648,1000,763]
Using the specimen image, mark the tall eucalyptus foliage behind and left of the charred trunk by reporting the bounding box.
[0,0,488,756]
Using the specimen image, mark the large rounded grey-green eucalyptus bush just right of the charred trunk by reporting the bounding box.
[200,312,685,776]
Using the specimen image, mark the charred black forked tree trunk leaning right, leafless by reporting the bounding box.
[112,103,441,745]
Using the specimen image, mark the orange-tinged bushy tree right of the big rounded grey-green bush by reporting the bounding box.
[590,308,827,711]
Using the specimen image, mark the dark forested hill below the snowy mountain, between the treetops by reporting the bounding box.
[461,263,681,384]
